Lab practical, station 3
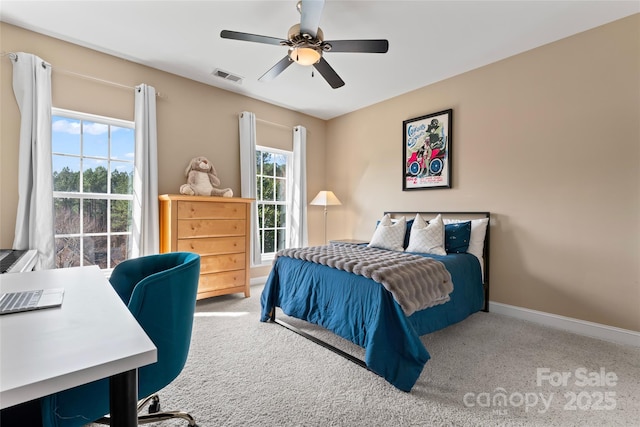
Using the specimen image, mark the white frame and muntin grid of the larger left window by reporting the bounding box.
[51,107,135,275]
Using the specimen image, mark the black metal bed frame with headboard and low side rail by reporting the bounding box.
[269,211,491,372]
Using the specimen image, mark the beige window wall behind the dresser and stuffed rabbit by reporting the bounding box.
[0,23,326,277]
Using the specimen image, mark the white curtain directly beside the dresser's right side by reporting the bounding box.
[240,111,262,267]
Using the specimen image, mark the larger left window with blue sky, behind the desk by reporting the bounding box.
[51,108,135,269]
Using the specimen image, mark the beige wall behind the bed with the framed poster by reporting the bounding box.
[327,15,640,331]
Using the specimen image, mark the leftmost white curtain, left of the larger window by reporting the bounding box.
[11,52,55,270]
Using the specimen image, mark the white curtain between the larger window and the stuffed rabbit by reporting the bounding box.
[131,84,160,258]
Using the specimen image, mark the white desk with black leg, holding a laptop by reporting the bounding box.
[0,266,157,426]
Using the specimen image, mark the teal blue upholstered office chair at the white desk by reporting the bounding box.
[41,252,200,427]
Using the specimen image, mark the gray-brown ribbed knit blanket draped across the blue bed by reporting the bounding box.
[276,243,453,316]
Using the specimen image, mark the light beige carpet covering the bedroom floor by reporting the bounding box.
[107,287,640,427]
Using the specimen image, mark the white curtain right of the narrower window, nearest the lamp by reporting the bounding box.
[287,126,309,248]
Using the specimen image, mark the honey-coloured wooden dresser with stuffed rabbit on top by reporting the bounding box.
[159,194,253,299]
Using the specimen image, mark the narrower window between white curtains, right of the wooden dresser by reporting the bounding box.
[256,146,291,261]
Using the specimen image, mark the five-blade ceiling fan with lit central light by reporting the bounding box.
[220,0,389,89]
